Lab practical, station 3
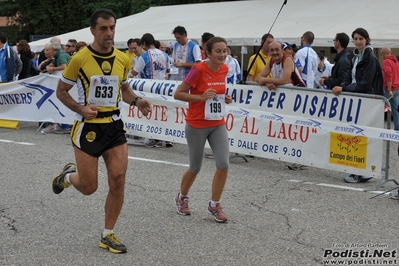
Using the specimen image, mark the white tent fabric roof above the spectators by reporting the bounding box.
[30,0,399,51]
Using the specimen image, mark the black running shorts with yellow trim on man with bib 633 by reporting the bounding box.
[71,119,127,158]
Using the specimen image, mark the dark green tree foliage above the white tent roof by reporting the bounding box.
[0,0,236,44]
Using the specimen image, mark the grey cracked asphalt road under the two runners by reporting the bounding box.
[0,122,399,265]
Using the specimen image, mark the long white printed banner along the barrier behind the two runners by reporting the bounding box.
[0,73,388,177]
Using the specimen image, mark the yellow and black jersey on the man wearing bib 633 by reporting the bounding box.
[61,46,132,123]
